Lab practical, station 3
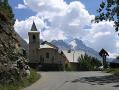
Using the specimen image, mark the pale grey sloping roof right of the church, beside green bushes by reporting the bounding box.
[63,50,85,62]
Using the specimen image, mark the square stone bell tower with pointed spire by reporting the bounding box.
[28,22,40,63]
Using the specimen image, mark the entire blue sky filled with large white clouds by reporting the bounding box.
[9,0,119,57]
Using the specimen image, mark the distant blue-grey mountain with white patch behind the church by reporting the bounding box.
[51,39,101,59]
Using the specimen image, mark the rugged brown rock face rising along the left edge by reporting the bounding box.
[0,0,28,84]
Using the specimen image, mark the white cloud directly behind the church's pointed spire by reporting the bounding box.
[14,16,45,42]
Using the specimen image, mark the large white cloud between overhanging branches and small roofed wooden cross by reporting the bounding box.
[85,21,118,53]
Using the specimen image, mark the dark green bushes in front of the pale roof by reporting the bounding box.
[78,54,101,71]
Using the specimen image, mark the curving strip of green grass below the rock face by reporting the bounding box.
[0,69,40,90]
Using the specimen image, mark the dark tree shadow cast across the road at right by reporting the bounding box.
[71,75,119,87]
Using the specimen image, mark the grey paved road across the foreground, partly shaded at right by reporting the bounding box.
[24,72,119,90]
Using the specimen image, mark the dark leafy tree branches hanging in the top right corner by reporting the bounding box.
[93,0,119,31]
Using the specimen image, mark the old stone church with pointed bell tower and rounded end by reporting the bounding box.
[28,22,68,70]
